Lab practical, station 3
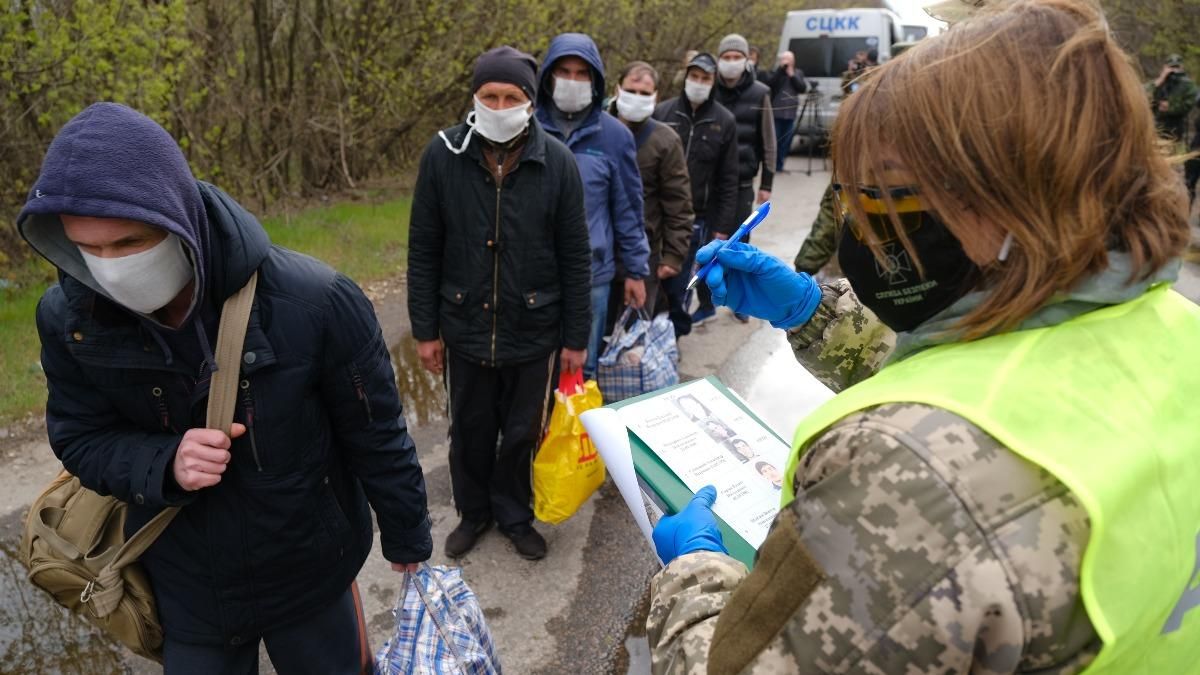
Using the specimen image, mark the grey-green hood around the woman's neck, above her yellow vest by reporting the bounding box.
[887,251,1183,363]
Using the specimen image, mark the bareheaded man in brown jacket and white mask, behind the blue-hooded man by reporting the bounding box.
[608,61,695,317]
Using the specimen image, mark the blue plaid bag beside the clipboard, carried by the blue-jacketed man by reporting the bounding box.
[596,307,679,404]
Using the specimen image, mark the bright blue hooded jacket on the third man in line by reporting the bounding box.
[535,32,650,285]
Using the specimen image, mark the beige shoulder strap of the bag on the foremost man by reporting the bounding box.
[91,271,258,600]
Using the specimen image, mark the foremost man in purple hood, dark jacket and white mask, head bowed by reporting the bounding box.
[17,103,432,674]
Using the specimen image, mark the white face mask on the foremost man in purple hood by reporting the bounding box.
[79,229,193,313]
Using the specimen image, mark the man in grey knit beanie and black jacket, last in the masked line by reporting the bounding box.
[710,32,776,323]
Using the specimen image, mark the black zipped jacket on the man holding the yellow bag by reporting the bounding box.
[408,119,592,366]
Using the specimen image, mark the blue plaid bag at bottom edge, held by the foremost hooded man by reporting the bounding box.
[374,562,500,675]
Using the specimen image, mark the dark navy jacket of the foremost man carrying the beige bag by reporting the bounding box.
[29,185,432,645]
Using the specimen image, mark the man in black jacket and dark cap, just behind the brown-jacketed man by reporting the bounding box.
[654,53,738,338]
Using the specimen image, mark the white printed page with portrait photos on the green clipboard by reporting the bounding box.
[618,380,791,549]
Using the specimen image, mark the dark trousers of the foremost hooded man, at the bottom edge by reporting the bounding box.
[162,584,374,675]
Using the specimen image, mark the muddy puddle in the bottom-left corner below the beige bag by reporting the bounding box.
[0,542,128,675]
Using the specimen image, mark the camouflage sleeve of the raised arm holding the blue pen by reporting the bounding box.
[787,279,896,392]
